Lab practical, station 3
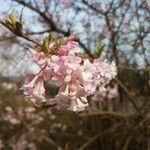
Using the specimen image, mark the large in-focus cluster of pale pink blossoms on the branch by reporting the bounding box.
[21,35,117,112]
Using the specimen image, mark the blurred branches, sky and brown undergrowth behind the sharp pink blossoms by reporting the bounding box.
[0,0,150,150]
